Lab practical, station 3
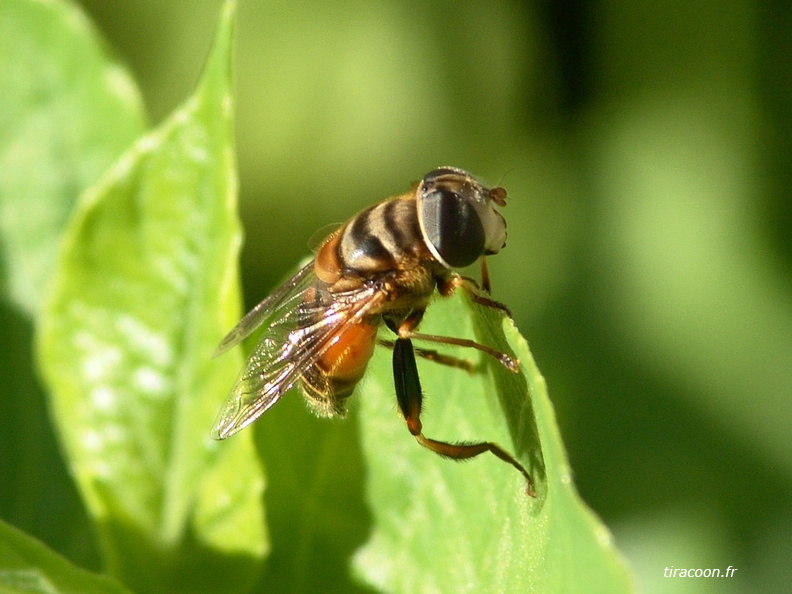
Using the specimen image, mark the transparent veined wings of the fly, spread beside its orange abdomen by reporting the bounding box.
[212,263,384,439]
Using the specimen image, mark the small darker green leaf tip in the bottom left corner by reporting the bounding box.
[0,522,127,594]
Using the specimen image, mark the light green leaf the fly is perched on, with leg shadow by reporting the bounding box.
[354,295,631,592]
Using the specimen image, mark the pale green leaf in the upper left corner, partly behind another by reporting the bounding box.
[0,0,144,315]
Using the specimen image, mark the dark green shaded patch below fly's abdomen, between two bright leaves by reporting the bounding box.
[255,390,371,593]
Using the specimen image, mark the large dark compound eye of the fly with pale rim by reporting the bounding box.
[419,189,485,268]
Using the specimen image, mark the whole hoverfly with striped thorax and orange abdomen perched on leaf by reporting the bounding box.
[212,167,533,494]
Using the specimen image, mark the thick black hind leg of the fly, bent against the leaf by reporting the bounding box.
[393,338,535,497]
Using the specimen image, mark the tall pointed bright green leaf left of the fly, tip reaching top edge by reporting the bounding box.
[38,2,267,592]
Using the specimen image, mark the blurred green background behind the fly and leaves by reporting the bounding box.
[0,0,792,592]
